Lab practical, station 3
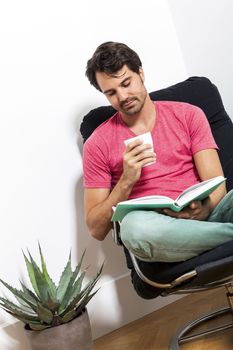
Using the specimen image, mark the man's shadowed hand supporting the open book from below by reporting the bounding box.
[162,197,211,221]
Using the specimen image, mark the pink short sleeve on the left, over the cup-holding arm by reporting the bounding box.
[83,137,111,188]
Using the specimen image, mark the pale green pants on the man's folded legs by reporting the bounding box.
[121,190,233,262]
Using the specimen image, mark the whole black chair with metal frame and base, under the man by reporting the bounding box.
[80,77,233,350]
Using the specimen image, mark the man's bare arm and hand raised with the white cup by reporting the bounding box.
[84,140,155,240]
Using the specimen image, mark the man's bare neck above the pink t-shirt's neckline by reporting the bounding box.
[121,95,156,135]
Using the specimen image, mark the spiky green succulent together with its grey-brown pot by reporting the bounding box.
[0,244,103,350]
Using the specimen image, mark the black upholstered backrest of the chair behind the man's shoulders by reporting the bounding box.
[80,77,233,191]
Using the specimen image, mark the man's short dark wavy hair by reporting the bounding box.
[86,41,142,91]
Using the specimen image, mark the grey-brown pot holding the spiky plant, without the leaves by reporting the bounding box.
[25,311,92,350]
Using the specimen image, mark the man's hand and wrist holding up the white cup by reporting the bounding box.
[122,140,156,185]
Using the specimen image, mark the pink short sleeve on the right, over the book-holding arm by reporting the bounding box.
[187,106,218,154]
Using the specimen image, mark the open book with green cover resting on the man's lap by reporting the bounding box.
[112,176,226,221]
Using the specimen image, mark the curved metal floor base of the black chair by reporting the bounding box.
[170,307,233,350]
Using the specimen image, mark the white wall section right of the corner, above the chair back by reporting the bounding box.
[168,0,233,118]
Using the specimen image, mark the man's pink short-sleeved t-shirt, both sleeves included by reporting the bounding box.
[83,101,218,199]
